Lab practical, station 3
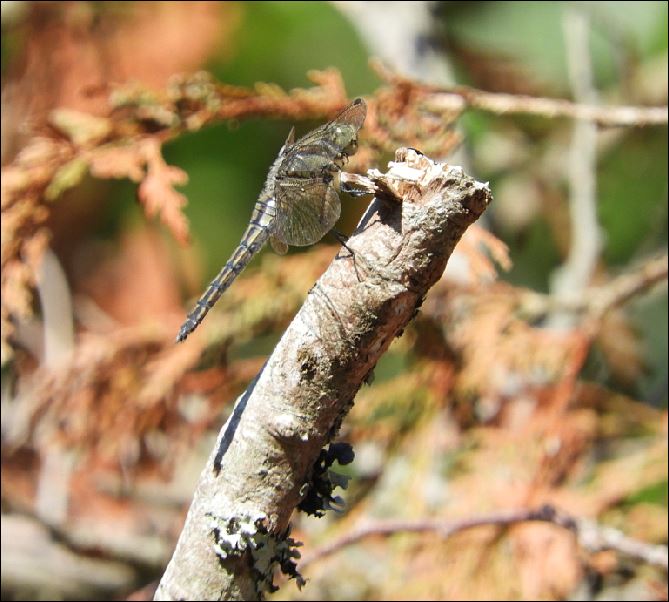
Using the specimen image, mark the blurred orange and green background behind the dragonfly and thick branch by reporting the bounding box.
[1,2,667,600]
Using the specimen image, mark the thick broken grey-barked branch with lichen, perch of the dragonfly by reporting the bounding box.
[154,149,491,600]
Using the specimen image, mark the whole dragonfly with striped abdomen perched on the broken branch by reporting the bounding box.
[176,98,367,342]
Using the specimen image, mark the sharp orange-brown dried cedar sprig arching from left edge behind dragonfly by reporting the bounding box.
[2,61,468,363]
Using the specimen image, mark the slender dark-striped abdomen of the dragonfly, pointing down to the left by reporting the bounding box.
[177,201,274,342]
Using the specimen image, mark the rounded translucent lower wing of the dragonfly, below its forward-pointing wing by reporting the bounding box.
[274,178,341,247]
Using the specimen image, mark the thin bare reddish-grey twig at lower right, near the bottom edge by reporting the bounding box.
[300,505,668,570]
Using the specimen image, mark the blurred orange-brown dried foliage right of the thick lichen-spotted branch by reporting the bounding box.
[300,282,667,599]
